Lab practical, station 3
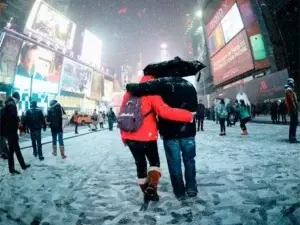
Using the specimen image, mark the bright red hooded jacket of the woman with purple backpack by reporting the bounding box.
[120,76,193,142]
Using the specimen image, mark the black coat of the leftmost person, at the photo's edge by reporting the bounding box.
[0,97,20,137]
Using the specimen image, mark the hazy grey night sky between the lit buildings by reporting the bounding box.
[72,0,196,69]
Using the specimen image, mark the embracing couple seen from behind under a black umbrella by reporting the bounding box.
[118,57,204,201]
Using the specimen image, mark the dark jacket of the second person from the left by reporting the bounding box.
[23,108,46,130]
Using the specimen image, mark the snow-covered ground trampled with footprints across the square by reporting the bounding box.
[0,122,300,225]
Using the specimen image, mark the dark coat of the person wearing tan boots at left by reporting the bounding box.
[47,101,66,133]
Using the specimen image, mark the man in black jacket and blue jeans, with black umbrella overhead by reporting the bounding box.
[126,57,205,199]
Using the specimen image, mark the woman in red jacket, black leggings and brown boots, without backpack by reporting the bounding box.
[120,76,193,201]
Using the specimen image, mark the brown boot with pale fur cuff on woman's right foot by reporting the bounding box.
[145,166,161,201]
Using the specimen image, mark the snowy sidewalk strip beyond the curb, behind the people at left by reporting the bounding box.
[20,126,115,149]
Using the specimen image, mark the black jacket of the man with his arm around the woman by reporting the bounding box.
[126,77,197,140]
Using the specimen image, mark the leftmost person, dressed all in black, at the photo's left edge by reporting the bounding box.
[1,92,30,174]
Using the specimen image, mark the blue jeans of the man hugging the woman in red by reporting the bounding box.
[164,137,198,197]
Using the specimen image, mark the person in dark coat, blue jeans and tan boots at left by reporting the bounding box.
[47,100,67,159]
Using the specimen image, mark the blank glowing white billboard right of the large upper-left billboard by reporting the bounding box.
[81,30,102,68]
